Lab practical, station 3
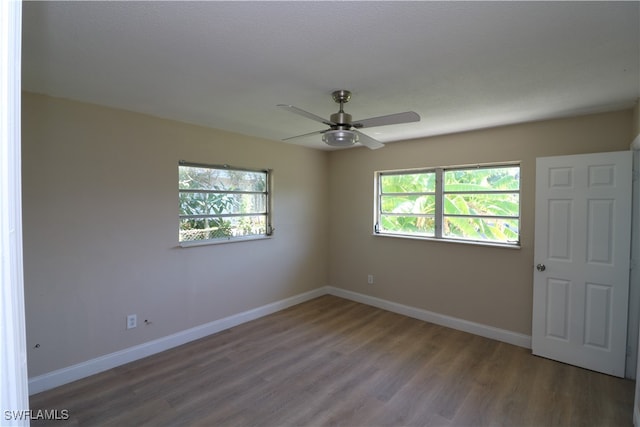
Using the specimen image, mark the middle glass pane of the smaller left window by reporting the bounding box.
[180,192,267,215]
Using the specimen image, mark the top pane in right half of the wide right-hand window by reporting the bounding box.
[444,166,520,192]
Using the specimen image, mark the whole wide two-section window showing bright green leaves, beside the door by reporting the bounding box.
[375,164,520,245]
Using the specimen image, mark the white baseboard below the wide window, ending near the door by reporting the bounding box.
[327,286,531,348]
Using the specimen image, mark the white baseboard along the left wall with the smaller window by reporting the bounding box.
[29,288,327,395]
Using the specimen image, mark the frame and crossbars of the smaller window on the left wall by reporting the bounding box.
[178,160,274,247]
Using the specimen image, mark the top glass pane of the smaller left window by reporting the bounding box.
[178,166,267,191]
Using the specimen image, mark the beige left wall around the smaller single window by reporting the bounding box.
[22,94,328,377]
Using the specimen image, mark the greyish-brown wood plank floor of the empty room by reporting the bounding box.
[31,295,634,426]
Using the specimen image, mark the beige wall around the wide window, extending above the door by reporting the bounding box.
[329,110,633,334]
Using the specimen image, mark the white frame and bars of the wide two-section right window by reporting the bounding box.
[373,162,522,248]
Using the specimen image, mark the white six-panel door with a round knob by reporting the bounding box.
[532,151,632,377]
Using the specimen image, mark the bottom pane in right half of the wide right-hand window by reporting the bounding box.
[443,216,520,242]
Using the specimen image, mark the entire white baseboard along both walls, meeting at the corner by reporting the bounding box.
[29,286,531,394]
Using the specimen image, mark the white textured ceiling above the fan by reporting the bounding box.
[22,1,640,149]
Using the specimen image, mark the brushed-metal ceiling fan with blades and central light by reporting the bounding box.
[278,90,420,150]
